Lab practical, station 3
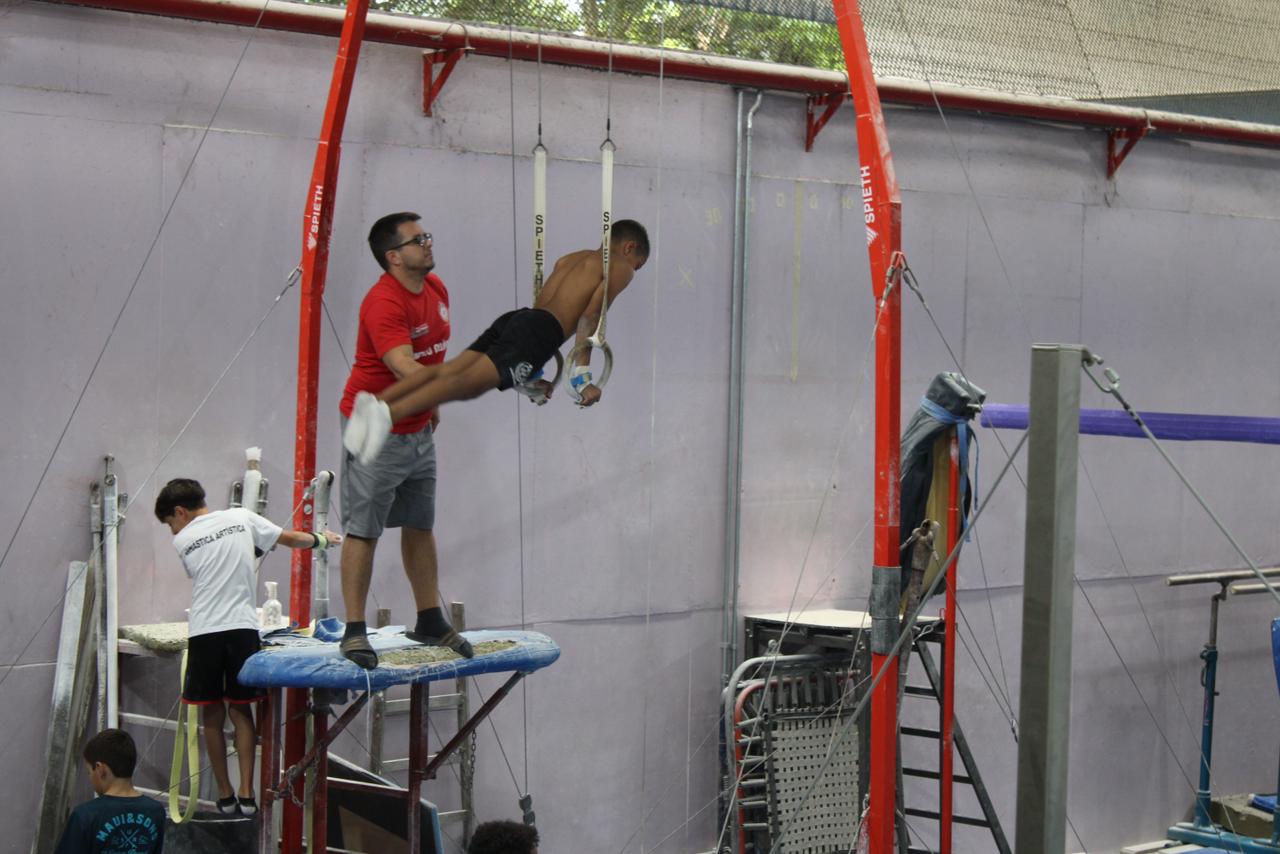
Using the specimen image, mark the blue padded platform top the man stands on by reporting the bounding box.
[238,626,559,691]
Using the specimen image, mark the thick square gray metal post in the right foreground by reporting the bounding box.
[1015,344,1084,854]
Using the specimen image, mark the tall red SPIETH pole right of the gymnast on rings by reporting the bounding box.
[832,0,902,854]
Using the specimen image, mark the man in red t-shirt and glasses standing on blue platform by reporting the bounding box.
[339,211,472,667]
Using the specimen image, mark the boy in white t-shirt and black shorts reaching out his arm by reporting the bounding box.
[156,478,342,816]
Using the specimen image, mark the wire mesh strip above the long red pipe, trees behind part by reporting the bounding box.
[309,0,1280,123]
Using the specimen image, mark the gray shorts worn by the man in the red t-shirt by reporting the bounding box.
[339,419,435,539]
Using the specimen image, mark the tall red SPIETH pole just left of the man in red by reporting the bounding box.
[280,0,369,854]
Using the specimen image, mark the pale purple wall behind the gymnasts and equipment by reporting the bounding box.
[0,3,1280,854]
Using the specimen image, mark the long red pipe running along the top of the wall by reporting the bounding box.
[49,0,1280,146]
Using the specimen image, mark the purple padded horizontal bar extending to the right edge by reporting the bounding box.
[982,403,1280,444]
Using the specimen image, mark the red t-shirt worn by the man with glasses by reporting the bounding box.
[338,273,449,433]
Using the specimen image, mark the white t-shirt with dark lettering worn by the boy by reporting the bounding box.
[173,507,282,638]
